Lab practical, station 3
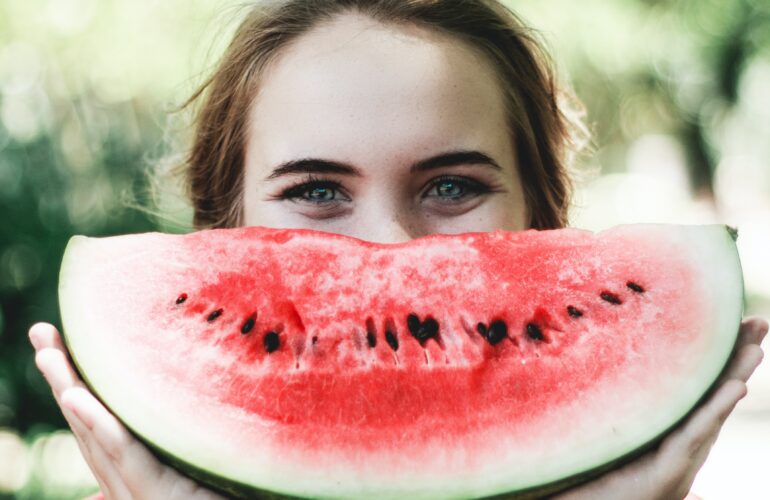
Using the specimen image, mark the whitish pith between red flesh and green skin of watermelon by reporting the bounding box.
[59,226,743,499]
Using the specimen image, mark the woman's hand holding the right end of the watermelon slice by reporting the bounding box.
[554,318,768,500]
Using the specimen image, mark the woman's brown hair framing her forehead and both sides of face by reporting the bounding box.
[183,0,577,229]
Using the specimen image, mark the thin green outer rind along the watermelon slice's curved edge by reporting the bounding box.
[59,226,743,499]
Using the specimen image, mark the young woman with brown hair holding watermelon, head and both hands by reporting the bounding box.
[30,0,767,499]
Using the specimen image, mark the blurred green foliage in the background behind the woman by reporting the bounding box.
[0,0,770,498]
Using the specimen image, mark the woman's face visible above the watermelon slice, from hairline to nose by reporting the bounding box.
[244,14,529,242]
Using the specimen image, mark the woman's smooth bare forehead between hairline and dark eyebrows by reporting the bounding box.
[247,14,510,170]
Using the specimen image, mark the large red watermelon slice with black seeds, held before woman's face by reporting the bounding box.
[59,225,743,499]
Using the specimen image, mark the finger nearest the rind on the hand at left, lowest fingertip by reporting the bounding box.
[62,388,165,494]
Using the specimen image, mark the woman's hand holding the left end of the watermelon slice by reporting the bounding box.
[29,323,221,500]
